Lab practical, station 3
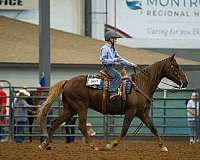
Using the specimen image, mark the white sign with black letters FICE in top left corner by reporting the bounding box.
[0,0,39,10]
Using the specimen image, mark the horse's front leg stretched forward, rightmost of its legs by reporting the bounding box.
[139,112,168,152]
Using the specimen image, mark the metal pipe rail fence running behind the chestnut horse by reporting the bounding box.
[0,81,200,141]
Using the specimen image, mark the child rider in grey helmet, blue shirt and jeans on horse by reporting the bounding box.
[100,31,137,101]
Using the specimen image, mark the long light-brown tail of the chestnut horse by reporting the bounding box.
[38,80,67,133]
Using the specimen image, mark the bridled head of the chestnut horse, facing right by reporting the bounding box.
[164,54,188,88]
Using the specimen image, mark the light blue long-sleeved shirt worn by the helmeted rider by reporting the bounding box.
[100,43,135,67]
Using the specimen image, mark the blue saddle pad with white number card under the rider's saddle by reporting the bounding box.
[86,75,132,94]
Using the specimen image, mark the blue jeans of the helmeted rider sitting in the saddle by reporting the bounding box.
[106,65,121,92]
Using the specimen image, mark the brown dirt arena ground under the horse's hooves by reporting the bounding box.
[0,140,200,160]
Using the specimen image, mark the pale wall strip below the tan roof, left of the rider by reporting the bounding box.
[0,66,99,87]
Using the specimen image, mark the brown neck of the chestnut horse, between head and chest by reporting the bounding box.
[137,61,164,97]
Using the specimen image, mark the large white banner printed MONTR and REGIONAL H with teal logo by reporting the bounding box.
[110,0,200,48]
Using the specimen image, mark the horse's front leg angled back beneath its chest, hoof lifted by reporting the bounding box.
[106,109,136,150]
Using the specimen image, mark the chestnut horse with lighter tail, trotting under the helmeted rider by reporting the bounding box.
[38,55,188,151]
